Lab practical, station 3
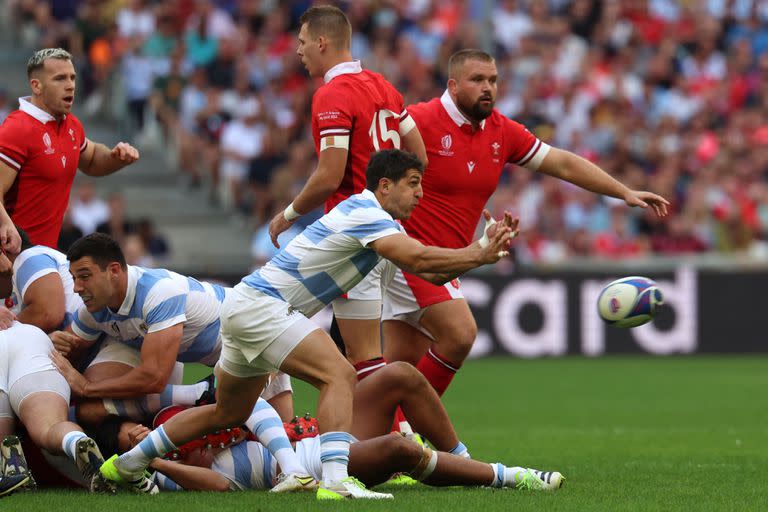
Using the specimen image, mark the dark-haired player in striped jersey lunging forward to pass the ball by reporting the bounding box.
[96,150,517,499]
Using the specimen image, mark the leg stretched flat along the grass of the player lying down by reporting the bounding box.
[349,434,565,490]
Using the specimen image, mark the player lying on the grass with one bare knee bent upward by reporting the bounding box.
[111,363,565,491]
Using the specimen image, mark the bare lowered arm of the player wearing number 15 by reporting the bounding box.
[269,148,349,248]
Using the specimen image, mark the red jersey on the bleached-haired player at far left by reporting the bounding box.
[0,98,87,249]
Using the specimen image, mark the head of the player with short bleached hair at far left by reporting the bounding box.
[27,48,77,118]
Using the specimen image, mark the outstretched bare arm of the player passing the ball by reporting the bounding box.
[370,226,514,284]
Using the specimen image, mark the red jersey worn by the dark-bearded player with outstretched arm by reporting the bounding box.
[403,91,549,248]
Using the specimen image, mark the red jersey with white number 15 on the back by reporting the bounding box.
[312,61,415,213]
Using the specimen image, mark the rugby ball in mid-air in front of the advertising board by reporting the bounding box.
[597,276,664,328]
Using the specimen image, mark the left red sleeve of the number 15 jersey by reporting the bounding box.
[312,87,354,151]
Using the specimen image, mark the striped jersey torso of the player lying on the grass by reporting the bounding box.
[211,441,277,491]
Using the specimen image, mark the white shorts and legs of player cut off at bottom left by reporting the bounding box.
[0,322,114,492]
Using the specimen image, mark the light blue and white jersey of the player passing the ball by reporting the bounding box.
[243,190,405,317]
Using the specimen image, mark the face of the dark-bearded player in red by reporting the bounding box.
[448,59,498,122]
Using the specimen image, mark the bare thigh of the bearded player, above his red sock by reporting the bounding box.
[419,299,477,346]
